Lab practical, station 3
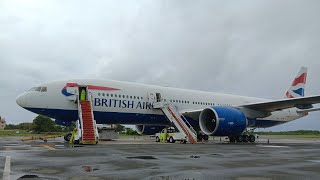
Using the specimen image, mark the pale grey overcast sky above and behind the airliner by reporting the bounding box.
[0,0,320,130]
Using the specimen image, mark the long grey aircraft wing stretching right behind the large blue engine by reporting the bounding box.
[240,96,320,112]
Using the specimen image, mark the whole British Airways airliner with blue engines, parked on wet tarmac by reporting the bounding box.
[16,67,320,142]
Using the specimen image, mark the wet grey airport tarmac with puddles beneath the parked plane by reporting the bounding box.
[0,137,320,180]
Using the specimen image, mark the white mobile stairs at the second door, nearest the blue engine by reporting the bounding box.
[153,101,197,144]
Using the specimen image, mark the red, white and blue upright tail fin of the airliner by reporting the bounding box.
[285,67,308,98]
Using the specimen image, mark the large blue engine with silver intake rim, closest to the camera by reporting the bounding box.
[199,106,248,136]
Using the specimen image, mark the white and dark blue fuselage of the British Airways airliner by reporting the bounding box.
[17,80,304,127]
